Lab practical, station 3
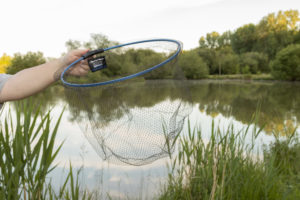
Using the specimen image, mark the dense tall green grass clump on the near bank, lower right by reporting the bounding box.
[159,123,300,200]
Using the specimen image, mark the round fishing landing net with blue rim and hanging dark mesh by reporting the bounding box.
[61,40,192,165]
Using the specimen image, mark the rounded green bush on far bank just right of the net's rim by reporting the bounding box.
[178,51,208,79]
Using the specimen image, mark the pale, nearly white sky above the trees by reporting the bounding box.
[0,0,300,57]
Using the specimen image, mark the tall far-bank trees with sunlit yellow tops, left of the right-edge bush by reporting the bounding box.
[197,10,300,78]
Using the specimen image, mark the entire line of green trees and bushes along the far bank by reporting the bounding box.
[5,10,300,81]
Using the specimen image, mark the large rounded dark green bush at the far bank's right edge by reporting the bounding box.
[271,44,300,81]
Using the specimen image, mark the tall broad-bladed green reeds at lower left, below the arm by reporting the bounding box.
[0,101,92,200]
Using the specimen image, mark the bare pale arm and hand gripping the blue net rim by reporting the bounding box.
[0,49,89,102]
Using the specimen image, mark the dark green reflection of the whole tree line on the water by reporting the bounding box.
[17,80,300,138]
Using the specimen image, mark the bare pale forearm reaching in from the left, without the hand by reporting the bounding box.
[0,59,64,102]
